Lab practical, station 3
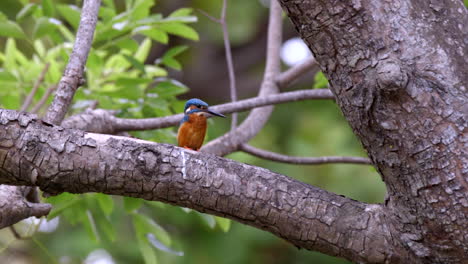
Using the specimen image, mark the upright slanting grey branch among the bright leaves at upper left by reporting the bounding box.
[44,0,101,124]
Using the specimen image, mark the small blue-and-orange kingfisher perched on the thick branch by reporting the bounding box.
[177,98,226,151]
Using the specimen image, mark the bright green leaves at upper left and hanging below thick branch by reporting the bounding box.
[0,0,229,263]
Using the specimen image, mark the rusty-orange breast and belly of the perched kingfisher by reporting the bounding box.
[177,114,206,150]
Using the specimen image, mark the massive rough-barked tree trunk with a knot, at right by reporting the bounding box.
[281,0,468,263]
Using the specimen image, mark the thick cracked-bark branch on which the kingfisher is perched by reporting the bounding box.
[0,110,406,263]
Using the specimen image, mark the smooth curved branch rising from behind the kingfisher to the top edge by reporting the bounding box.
[200,0,282,156]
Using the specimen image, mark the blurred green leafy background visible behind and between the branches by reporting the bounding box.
[0,0,385,263]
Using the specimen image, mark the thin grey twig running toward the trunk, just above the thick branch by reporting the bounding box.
[240,144,372,165]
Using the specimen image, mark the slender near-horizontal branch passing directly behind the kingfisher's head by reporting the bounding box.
[62,89,334,134]
